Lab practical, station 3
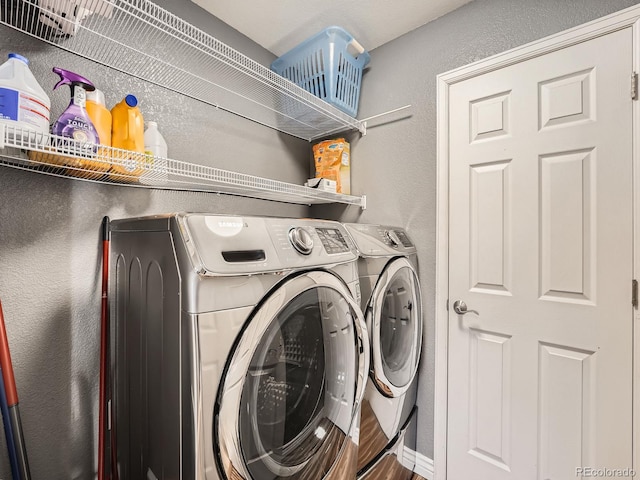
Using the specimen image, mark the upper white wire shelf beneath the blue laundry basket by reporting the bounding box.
[0,0,365,141]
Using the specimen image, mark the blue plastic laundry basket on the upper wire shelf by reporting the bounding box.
[271,26,370,117]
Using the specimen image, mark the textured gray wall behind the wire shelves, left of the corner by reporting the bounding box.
[0,1,309,480]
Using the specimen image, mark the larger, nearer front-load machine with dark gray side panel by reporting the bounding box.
[110,214,369,480]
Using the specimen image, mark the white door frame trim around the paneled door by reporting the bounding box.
[434,5,640,480]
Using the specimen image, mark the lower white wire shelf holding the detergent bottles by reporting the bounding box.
[0,123,365,208]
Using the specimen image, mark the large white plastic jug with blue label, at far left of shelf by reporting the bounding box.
[0,53,51,138]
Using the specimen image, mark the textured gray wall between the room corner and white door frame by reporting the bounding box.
[312,0,639,458]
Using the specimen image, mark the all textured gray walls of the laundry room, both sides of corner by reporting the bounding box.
[0,0,640,479]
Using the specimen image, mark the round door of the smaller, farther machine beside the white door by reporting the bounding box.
[370,258,422,397]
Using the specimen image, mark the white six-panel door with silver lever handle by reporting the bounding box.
[447,28,633,480]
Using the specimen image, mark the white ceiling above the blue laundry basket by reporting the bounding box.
[192,0,470,56]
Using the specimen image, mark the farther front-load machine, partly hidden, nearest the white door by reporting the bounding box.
[345,224,423,480]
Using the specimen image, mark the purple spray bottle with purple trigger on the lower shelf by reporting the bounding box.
[51,67,100,154]
